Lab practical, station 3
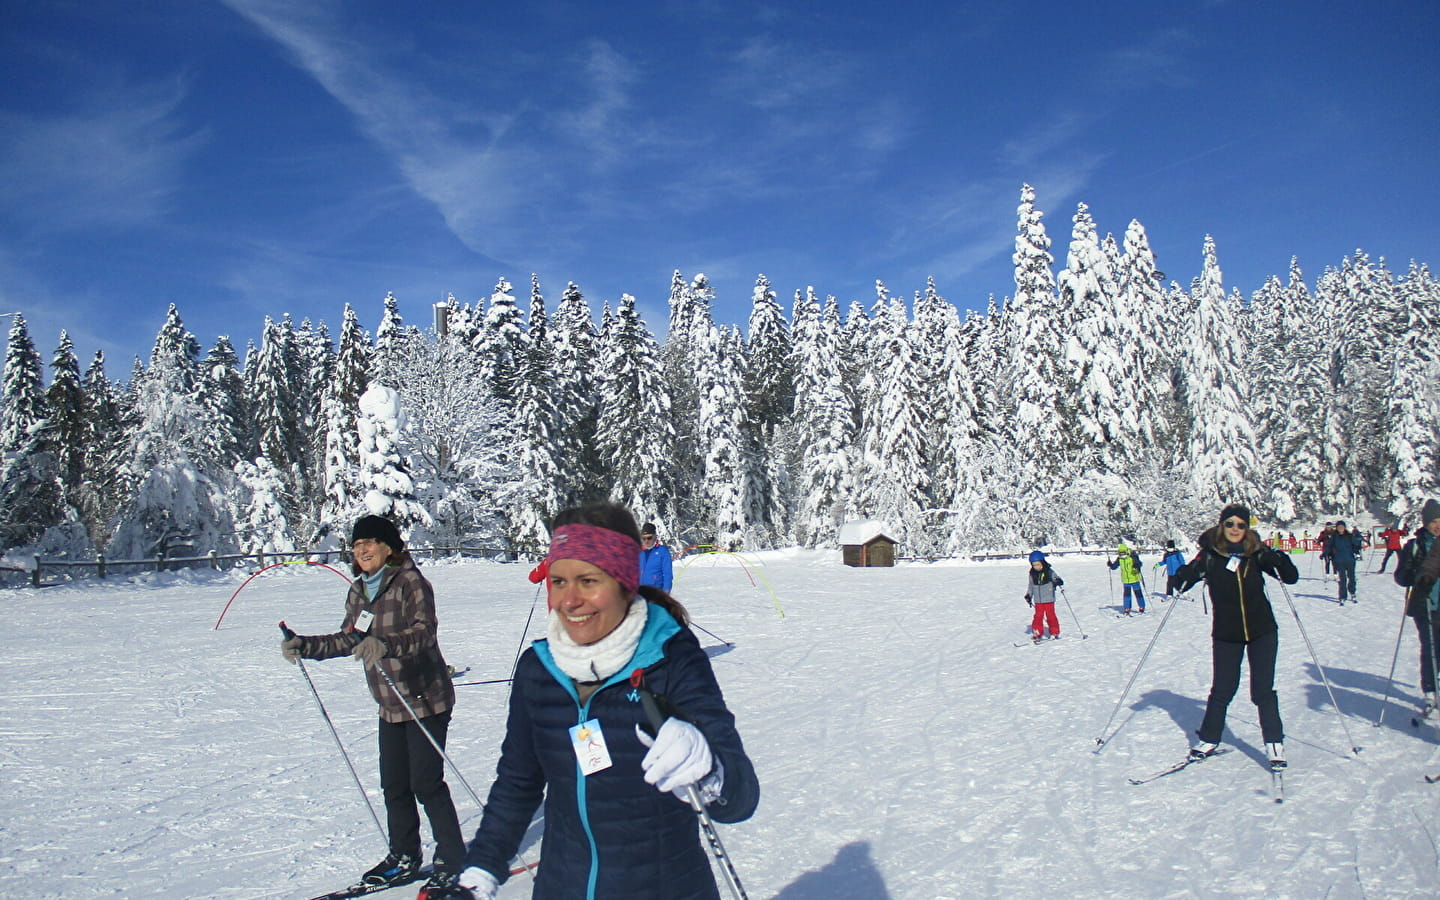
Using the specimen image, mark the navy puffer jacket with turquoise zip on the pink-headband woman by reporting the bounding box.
[465,603,760,900]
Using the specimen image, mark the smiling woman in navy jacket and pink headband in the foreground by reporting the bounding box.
[452,504,760,900]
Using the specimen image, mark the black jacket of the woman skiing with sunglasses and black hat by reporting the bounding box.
[1175,526,1300,644]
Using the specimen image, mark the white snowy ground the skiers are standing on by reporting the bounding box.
[0,552,1440,900]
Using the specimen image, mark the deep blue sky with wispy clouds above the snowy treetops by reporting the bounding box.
[0,0,1440,377]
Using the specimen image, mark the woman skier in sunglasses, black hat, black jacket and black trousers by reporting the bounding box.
[1176,504,1300,769]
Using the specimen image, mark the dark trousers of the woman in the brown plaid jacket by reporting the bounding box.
[380,713,465,871]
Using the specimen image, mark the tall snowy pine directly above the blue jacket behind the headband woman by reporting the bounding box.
[595,294,675,531]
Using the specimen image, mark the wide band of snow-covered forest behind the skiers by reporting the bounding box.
[0,184,1440,559]
